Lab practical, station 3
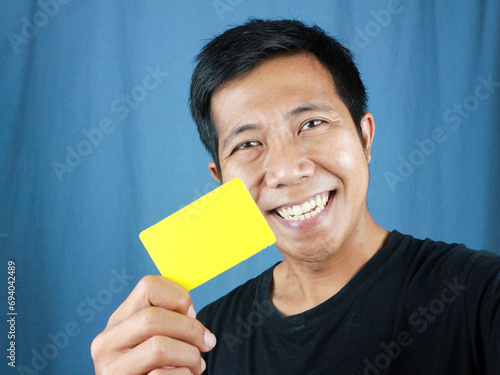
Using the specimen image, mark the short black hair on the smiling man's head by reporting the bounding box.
[189,19,367,177]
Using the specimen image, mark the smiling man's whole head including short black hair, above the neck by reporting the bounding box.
[191,21,375,262]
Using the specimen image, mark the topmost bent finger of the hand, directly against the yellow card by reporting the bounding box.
[107,275,195,327]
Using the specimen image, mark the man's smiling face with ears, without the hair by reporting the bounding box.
[210,54,374,261]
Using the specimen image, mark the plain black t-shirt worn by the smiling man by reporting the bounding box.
[198,231,500,375]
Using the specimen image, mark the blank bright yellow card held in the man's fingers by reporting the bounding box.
[139,178,276,290]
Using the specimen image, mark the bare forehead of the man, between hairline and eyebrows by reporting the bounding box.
[211,53,341,126]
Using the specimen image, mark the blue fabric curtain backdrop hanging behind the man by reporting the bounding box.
[0,0,500,374]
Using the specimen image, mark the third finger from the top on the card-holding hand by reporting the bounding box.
[107,336,204,375]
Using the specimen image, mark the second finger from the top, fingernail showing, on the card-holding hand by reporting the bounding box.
[94,307,216,353]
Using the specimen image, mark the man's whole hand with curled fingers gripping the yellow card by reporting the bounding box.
[91,276,216,375]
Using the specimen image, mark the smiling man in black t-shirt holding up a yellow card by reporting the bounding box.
[92,20,500,375]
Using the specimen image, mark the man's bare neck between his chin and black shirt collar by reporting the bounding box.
[271,213,389,316]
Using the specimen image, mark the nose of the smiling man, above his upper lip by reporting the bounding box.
[265,144,314,188]
